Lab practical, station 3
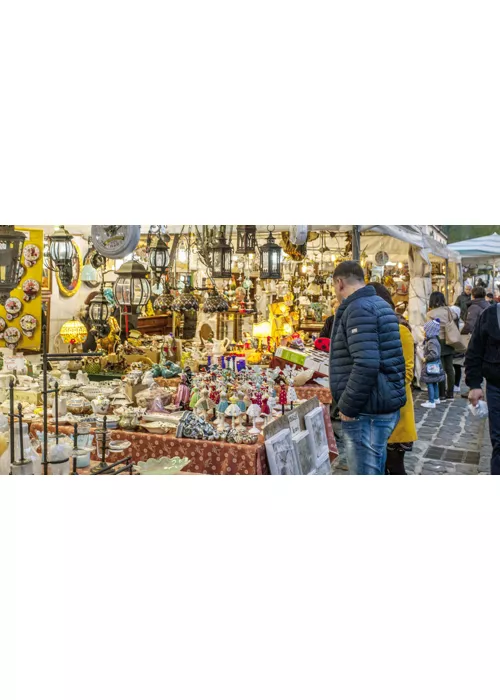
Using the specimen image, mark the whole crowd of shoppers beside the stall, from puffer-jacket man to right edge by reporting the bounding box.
[321,261,500,475]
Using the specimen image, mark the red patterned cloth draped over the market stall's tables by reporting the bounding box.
[31,406,338,474]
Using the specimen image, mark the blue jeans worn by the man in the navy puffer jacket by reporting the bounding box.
[342,411,399,474]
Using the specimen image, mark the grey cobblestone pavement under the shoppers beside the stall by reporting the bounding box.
[333,391,491,475]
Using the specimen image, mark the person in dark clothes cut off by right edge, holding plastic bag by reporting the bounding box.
[465,304,500,474]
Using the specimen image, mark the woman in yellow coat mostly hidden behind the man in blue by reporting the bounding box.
[371,282,417,474]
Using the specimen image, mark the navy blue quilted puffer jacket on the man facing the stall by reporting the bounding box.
[330,286,406,418]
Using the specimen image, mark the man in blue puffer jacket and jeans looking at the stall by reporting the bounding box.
[330,262,406,474]
